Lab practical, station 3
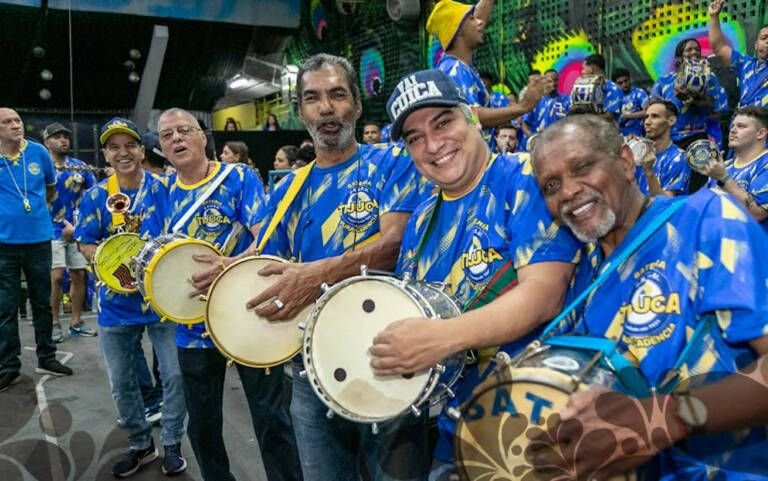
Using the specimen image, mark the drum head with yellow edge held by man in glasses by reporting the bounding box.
[145,240,219,322]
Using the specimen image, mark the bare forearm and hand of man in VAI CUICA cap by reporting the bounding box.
[370,262,573,376]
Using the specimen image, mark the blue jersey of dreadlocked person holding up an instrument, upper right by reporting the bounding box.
[651,72,728,142]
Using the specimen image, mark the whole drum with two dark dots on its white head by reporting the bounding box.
[302,275,465,423]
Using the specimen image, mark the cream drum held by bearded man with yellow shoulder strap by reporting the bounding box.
[205,256,312,368]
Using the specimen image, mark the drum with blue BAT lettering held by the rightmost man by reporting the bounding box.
[455,336,630,481]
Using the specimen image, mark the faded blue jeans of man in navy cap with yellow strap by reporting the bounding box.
[99,322,186,449]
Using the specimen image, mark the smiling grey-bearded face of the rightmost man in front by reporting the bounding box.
[535,125,635,242]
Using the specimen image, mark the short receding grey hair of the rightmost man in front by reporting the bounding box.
[531,114,624,170]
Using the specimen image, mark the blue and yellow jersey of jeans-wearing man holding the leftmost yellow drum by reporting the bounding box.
[75,171,167,327]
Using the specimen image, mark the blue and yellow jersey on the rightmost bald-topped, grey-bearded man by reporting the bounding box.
[573,189,768,480]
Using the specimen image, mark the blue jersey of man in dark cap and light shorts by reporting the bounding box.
[51,156,96,239]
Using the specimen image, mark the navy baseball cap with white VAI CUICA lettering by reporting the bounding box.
[387,70,468,141]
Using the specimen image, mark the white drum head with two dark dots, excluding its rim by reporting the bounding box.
[304,279,429,421]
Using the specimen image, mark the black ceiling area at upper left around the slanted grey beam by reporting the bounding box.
[0,2,290,113]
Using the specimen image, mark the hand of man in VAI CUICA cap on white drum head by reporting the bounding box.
[369,317,451,376]
